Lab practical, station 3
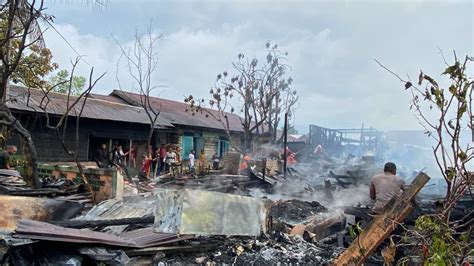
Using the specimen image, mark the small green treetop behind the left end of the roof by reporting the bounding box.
[49,69,86,95]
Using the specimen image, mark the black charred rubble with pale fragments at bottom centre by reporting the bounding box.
[155,231,342,265]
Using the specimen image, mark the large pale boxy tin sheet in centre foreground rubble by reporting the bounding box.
[155,189,266,236]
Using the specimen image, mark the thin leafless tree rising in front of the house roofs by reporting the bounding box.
[114,23,162,174]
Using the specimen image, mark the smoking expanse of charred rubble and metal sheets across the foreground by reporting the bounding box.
[0,153,466,265]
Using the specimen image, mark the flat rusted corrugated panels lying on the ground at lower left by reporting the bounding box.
[14,219,190,248]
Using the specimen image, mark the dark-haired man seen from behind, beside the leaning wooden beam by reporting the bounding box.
[370,162,405,214]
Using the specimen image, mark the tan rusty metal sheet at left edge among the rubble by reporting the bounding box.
[0,195,84,230]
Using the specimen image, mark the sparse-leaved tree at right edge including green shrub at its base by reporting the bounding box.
[375,52,474,265]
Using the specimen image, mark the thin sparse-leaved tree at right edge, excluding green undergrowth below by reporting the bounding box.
[376,53,474,218]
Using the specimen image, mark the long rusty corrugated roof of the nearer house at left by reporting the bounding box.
[7,86,173,127]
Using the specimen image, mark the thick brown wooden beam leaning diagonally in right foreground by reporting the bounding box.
[335,172,430,265]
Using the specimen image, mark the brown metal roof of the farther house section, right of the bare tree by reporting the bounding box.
[110,90,243,132]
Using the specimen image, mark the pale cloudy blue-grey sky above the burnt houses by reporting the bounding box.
[41,0,474,133]
